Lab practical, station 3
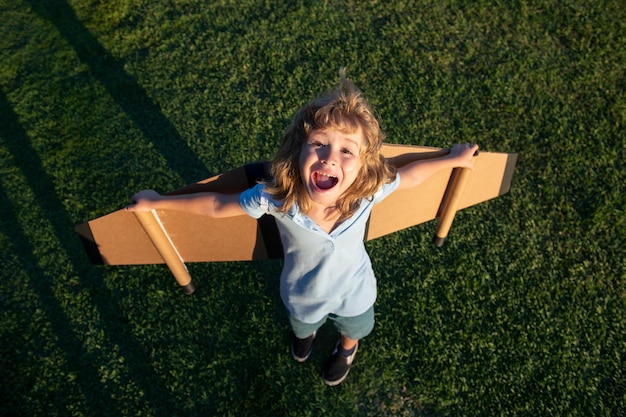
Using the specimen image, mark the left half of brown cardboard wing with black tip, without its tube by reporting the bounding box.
[76,164,282,265]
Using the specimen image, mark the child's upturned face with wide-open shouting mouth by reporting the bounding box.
[300,127,363,207]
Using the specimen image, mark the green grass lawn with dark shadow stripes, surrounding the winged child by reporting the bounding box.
[0,0,626,416]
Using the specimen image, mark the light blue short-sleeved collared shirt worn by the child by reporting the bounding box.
[239,175,400,323]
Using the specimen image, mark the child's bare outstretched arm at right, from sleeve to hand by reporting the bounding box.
[398,143,478,190]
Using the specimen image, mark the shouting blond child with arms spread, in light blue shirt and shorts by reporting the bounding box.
[127,71,478,386]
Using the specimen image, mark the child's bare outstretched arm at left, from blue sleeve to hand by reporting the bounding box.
[126,190,246,217]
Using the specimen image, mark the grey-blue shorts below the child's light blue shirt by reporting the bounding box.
[289,306,374,340]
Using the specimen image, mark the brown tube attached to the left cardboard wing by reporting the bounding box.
[134,210,195,294]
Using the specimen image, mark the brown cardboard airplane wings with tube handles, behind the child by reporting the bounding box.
[76,144,517,291]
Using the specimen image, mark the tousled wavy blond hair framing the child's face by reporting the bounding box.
[265,69,395,221]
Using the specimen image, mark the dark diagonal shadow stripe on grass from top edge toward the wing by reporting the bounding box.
[29,0,206,183]
